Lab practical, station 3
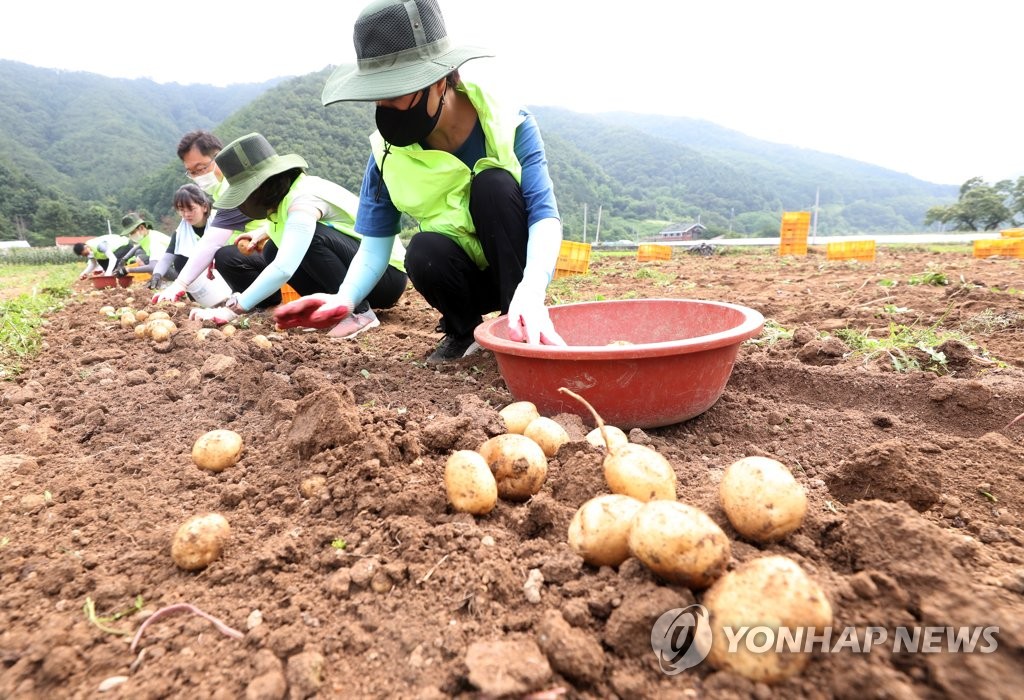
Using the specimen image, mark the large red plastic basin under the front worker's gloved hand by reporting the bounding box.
[474,299,764,430]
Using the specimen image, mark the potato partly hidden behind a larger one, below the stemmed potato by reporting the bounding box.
[568,493,643,566]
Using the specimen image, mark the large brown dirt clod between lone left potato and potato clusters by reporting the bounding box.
[287,389,359,460]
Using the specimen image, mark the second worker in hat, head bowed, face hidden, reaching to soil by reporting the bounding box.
[191,133,408,338]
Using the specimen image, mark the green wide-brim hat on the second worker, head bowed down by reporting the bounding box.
[213,133,308,209]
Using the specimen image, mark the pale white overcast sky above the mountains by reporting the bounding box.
[0,0,1024,185]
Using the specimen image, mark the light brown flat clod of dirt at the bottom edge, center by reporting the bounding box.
[466,640,552,697]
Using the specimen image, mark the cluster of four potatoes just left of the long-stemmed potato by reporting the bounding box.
[444,401,569,515]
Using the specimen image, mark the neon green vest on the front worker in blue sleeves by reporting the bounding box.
[370,83,525,270]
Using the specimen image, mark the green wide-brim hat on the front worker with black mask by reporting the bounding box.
[321,0,494,104]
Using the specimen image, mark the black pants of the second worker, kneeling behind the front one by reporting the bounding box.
[214,222,409,312]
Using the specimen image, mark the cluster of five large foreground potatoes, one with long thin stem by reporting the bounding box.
[561,389,833,683]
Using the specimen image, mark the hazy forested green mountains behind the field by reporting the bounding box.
[0,60,958,243]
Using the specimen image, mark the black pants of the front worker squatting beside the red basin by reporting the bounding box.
[406,168,529,336]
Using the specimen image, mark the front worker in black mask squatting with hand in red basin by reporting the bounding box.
[274,0,564,364]
